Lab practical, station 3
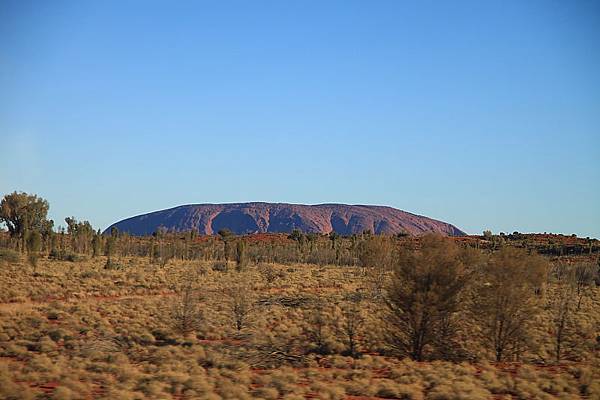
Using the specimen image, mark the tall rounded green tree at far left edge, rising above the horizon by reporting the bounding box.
[0,191,49,250]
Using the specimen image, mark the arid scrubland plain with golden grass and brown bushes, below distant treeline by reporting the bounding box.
[0,233,600,399]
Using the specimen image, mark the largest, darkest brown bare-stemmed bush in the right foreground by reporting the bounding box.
[384,235,478,361]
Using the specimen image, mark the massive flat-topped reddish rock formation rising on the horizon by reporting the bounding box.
[105,203,465,236]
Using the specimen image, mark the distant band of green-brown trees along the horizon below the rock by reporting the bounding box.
[0,192,600,266]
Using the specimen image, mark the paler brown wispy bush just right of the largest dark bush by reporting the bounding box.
[471,247,548,361]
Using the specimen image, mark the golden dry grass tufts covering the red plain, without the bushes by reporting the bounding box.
[0,258,600,400]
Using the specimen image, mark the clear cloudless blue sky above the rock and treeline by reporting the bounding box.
[0,0,600,237]
